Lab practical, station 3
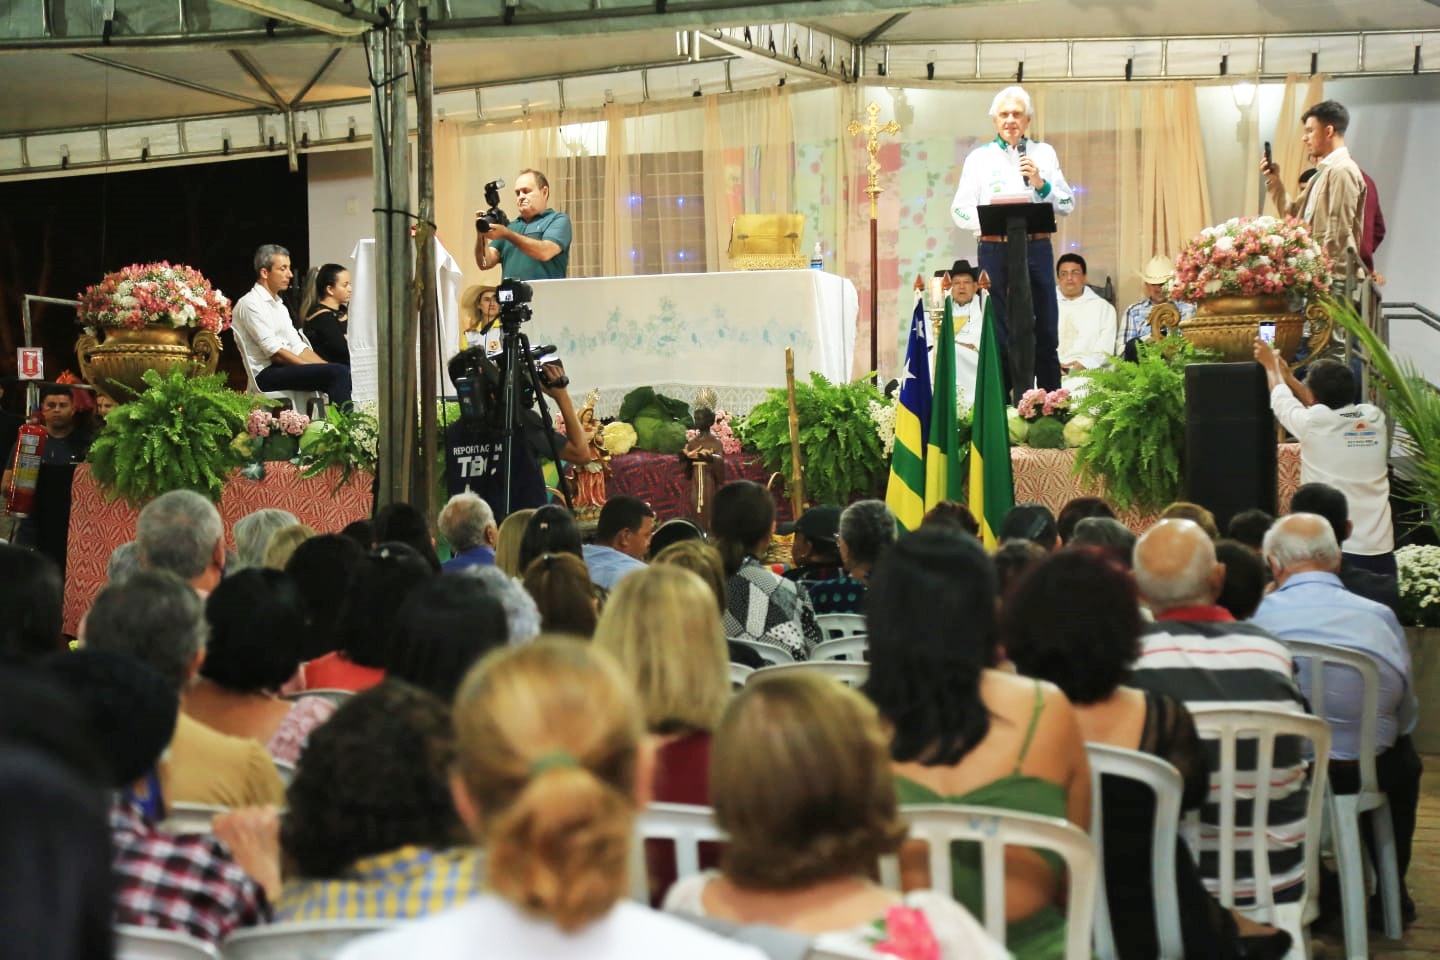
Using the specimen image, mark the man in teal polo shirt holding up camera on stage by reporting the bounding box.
[475,170,570,281]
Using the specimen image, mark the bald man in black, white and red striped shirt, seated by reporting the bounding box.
[1132,520,1308,915]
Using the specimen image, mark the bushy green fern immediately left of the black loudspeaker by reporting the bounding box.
[1076,335,1208,510]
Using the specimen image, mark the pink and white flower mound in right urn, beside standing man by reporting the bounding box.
[1171,217,1332,302]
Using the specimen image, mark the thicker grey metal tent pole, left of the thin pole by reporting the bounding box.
[366,3,415,508]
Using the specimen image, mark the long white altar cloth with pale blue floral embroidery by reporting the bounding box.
[527,271,860,416]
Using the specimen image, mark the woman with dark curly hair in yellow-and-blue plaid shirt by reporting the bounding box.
[267,681,480,920]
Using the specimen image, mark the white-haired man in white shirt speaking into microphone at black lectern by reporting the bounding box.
[950,86,1076,390]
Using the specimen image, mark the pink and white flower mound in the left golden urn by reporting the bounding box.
[76,262,230,334]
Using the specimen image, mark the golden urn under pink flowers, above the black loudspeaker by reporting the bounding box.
[1169,295,1335,364]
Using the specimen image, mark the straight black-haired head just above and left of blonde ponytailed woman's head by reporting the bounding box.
[386,574,510,704]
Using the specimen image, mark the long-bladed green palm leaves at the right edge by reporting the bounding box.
[1325,299,1440,535]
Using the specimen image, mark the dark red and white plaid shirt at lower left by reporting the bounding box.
[109,799,271,943]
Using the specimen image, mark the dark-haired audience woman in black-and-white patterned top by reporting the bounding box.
[710,481,825,661]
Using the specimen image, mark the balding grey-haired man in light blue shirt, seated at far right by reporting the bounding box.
[1253,514,1421,923]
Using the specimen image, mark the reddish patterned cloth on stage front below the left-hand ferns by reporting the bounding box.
[65,461,373,635]
